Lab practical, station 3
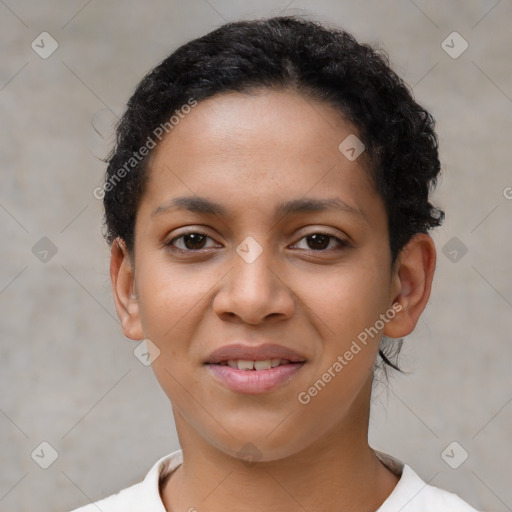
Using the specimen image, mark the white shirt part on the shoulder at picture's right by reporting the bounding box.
[377,453,478,512]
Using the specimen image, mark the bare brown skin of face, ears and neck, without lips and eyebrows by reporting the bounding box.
[111,90,436,512]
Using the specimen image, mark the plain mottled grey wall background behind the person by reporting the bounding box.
[0,0,512,512]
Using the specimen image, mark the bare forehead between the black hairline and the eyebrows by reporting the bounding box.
[140,90,378,222]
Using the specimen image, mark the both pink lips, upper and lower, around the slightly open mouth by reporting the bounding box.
[205,344,306,395]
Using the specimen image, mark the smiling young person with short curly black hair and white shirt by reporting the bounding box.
[72,17,475,512]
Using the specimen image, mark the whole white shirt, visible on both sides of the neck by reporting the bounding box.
[72,450,478,512]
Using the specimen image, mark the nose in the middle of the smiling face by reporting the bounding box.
[213,243,295,325]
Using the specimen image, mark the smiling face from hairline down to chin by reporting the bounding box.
[112,91,432,460]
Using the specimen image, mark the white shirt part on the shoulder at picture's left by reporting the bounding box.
[71,450,183,512]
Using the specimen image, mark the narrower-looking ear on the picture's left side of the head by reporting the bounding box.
[110,238,144,340]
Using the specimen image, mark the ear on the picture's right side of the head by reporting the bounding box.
[384,233,436,338]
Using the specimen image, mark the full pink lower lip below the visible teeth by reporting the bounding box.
[208,363,304,395]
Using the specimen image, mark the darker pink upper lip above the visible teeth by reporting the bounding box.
[205,343,306,364]
